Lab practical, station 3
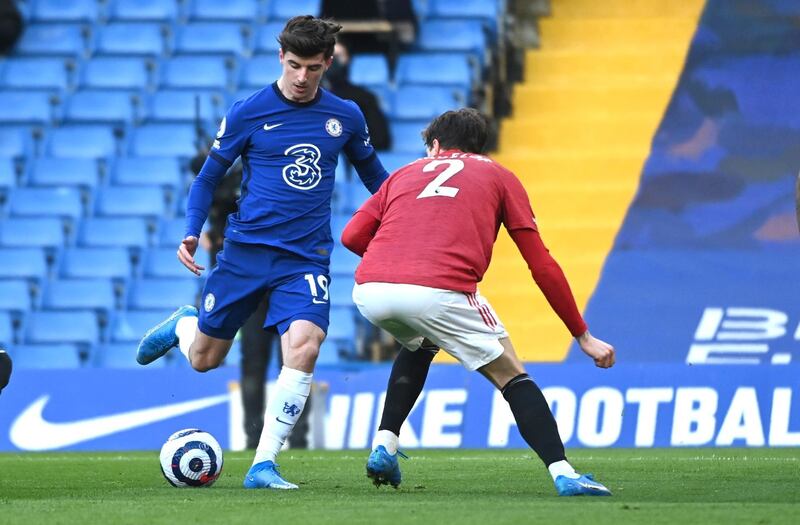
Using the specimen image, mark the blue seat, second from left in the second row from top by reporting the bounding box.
[96,22,165,56]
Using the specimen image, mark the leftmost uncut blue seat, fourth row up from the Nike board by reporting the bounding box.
[60,247,133,281]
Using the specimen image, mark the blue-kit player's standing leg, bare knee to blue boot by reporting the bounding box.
[244,319,325,489]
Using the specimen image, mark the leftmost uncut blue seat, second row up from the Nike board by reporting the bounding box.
[25,310,100,345]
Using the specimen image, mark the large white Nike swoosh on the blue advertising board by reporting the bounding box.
[9,394,229,451]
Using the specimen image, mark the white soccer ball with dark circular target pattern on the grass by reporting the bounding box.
[161,428,222,487]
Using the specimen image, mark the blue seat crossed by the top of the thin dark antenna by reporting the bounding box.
[146,89,225,124]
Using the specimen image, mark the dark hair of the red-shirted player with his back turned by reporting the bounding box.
[422,108,489,153]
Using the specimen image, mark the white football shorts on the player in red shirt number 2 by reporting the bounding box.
[353,283,508,370]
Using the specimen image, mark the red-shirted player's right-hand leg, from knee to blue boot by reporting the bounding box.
[478,338,611,496]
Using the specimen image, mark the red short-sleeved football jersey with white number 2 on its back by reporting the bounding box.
[356,150,536,292]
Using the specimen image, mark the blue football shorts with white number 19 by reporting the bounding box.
[198,240,330,339]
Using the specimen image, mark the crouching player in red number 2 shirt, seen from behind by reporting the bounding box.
[342,109,614,496]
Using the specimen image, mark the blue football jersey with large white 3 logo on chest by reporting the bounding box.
[209,82,382,264]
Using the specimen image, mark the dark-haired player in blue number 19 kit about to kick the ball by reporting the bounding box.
[136,16,388,489]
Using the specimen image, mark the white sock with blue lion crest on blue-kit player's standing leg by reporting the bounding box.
[253,366,313,465]
